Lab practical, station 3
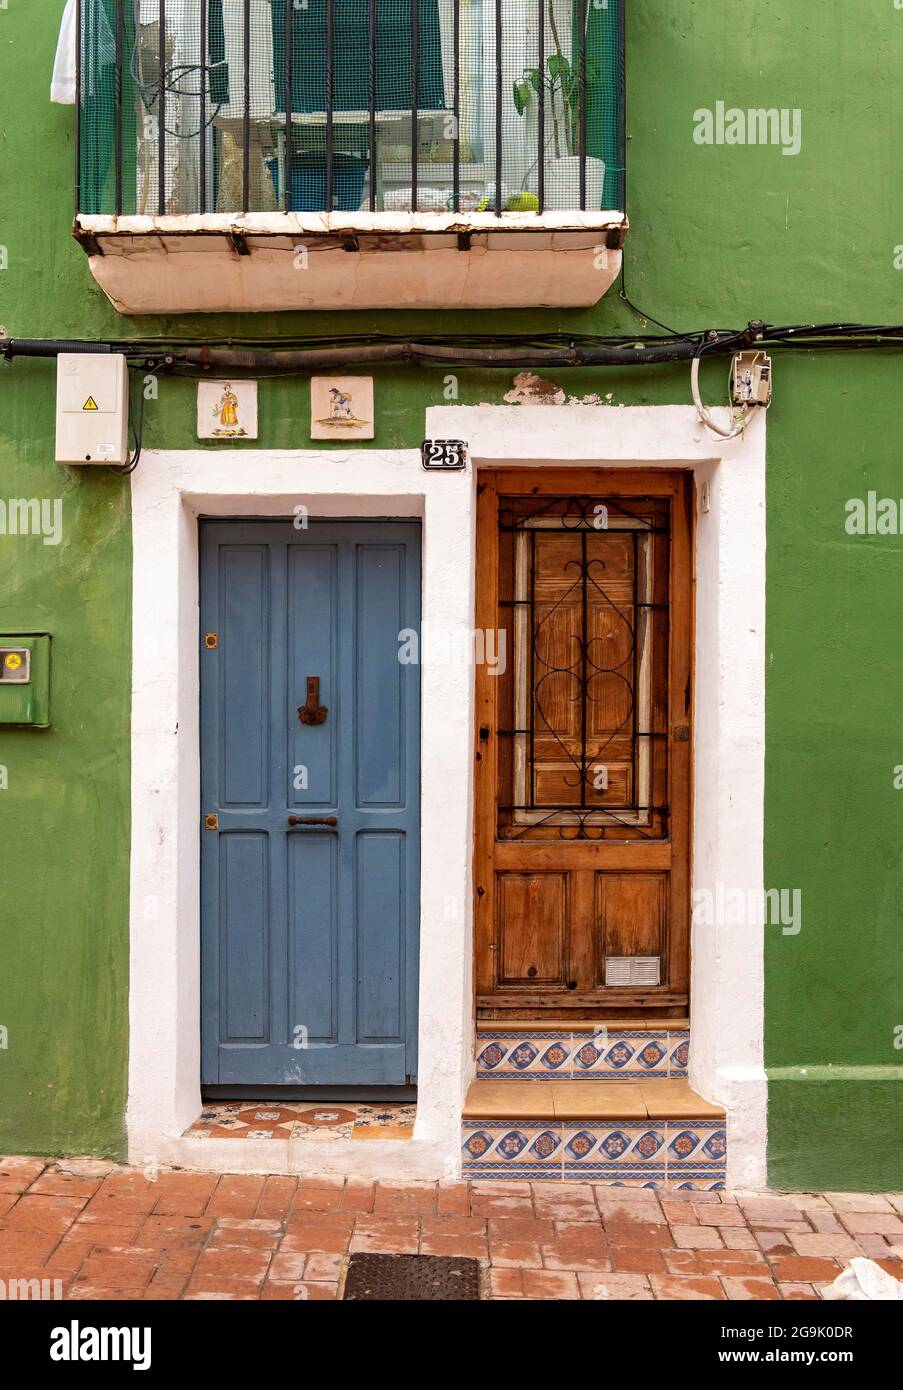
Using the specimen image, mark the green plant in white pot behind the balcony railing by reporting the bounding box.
[513,0,606,211]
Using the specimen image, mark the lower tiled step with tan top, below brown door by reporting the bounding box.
[461,1077,728,1190]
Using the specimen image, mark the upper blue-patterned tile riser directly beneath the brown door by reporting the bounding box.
[477,1024,690,1081]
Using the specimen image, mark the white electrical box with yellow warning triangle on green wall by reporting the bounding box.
[57,352,129,464]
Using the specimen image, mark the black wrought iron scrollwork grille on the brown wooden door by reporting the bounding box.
[499,496,670,840]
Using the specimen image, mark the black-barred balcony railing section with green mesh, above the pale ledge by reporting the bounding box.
[76,0,624,215]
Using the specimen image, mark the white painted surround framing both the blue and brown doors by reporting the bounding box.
[126,404,765,1187]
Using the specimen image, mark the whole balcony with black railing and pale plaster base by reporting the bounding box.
[75,0,627,314]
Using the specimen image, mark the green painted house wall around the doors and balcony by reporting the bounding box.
[0,0,903,1188]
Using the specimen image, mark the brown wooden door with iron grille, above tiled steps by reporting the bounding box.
[474,468,693,1019]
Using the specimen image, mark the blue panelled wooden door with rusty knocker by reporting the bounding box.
[200,521,420,1086]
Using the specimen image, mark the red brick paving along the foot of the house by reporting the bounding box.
[0,1158,903,1300]
